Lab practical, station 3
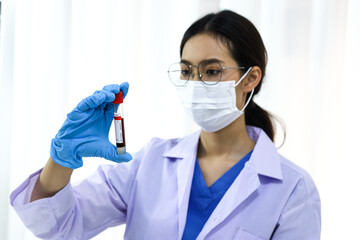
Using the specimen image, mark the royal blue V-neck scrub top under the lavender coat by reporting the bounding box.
[182,151,253,240]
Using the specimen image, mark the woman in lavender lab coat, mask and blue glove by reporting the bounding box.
[11,11,320,240]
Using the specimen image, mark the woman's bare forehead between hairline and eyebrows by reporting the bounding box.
[182,34,235,65]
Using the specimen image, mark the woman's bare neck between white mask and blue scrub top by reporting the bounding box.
[198,115,255,160]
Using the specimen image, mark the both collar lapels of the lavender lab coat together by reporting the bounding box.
[163,126,282,239]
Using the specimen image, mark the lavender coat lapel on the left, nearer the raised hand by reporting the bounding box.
[164,131,200,239]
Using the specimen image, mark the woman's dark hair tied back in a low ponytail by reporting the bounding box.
[180,10,275,141]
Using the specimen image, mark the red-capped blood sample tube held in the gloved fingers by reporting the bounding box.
[113,91,126,155]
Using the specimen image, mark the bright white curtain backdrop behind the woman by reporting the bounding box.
[0,0,360,240]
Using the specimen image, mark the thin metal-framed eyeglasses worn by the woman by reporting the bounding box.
[168,61,246,86]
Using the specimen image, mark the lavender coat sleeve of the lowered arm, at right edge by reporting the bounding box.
[271,172,321,240]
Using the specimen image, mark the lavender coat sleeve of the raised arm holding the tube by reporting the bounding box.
[10,155,140,239]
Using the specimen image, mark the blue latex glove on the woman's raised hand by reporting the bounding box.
[50,82,132,169]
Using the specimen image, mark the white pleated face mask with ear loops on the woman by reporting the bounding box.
[176,68,254,132]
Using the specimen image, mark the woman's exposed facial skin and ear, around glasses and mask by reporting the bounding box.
[181,34,245,109]
